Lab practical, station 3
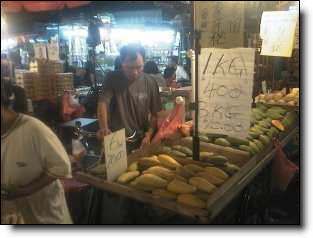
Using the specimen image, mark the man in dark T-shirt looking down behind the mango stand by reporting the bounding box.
[98,44,161,149]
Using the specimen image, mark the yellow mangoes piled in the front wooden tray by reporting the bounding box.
[116,153,239,209]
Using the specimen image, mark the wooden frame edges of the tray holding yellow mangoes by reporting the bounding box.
[76,139,252,224]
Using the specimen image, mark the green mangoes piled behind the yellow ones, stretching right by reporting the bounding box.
[174,103,298,159]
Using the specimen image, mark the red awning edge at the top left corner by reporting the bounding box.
[1,1,91,13]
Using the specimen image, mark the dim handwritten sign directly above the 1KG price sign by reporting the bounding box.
[195,1,245,48]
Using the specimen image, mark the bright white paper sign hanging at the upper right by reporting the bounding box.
[260,11,298,57]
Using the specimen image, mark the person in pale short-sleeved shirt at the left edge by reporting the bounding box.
[1,79,72,224]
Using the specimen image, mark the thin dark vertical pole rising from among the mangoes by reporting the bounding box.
[192,1,200,160]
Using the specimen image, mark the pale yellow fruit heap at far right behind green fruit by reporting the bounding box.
[255,88,299,107]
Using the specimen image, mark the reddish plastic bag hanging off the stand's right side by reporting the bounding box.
[272,140,299,191]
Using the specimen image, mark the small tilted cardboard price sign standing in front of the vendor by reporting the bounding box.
[104,129,127,181]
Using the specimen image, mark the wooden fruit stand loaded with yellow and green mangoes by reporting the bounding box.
[76,104,299,224]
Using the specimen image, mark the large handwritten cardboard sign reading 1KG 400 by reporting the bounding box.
[199,48,255,138]
